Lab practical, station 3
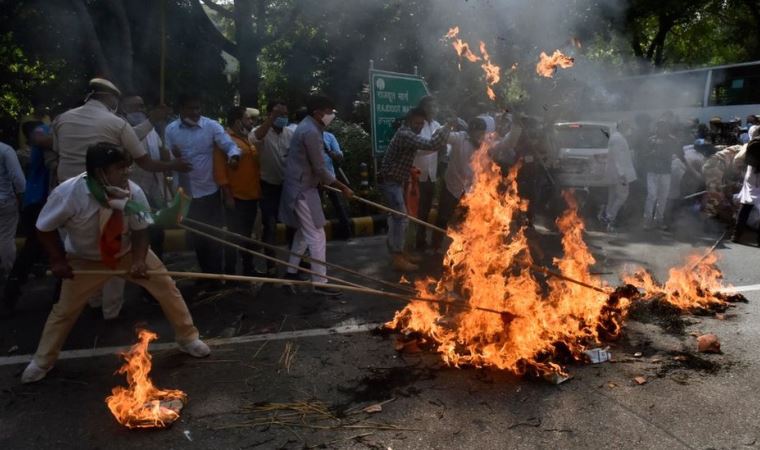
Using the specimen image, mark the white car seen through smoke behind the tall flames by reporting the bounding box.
[550,121,617,188]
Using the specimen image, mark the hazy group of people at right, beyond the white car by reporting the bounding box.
[598,113,760,236]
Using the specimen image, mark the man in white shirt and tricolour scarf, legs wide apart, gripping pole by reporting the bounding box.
[21,143,210,383]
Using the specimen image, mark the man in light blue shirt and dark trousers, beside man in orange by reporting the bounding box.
[164,93,241,289]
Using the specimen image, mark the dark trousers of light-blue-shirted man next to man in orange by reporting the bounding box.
[187,191,224,273]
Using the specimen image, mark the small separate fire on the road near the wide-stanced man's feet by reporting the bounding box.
[106,330,187,428]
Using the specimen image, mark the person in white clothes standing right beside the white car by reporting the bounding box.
[599,122,636,232]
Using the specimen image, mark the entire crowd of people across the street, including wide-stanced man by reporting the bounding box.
[0,78,760,382]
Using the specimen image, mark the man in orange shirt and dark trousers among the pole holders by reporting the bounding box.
[214,106,261,276]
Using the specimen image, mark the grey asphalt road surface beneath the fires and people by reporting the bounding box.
[0,211,760,449]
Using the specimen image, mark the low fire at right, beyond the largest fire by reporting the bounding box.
[622,252,730,311]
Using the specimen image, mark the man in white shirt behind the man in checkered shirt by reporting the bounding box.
[407,96,441,251]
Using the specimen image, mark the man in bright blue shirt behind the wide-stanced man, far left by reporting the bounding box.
[0,121,53,317]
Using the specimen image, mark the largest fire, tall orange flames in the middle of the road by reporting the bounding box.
[388,138,629,375]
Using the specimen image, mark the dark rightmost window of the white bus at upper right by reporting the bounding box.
[709,64,760,106]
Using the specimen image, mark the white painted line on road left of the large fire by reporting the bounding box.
[0,323,382,366]
